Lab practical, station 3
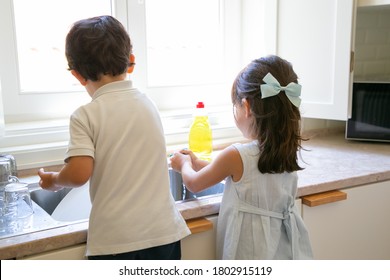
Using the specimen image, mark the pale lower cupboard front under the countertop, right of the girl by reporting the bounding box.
[302,181,390,260]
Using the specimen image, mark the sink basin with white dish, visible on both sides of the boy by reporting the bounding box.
[29,169,225,221]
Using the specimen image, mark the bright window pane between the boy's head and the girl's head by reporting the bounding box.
[128,0,241,112]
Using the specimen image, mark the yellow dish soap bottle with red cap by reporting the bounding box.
[188,102,213,161]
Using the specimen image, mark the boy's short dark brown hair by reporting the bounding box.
[65,16,132,81]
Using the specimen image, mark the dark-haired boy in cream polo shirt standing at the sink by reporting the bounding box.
[39,16,190,259]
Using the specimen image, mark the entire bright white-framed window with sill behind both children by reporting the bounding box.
[0,0,276,169]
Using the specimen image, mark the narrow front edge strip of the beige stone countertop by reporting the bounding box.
[0,172,390,260]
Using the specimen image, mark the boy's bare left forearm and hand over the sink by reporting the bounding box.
[38,156,94,191]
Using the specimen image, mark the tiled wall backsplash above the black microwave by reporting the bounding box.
[354,5,390,81]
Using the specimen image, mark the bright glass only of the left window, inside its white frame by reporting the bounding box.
[13,0,111,94]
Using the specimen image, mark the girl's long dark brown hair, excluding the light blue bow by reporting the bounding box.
[232,55,302,173]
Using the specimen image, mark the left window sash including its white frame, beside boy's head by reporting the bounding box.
[0,0,112,123]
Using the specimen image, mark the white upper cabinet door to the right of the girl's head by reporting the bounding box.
[277,0,354,120]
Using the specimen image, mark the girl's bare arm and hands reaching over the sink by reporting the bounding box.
[171,146,243,193]
